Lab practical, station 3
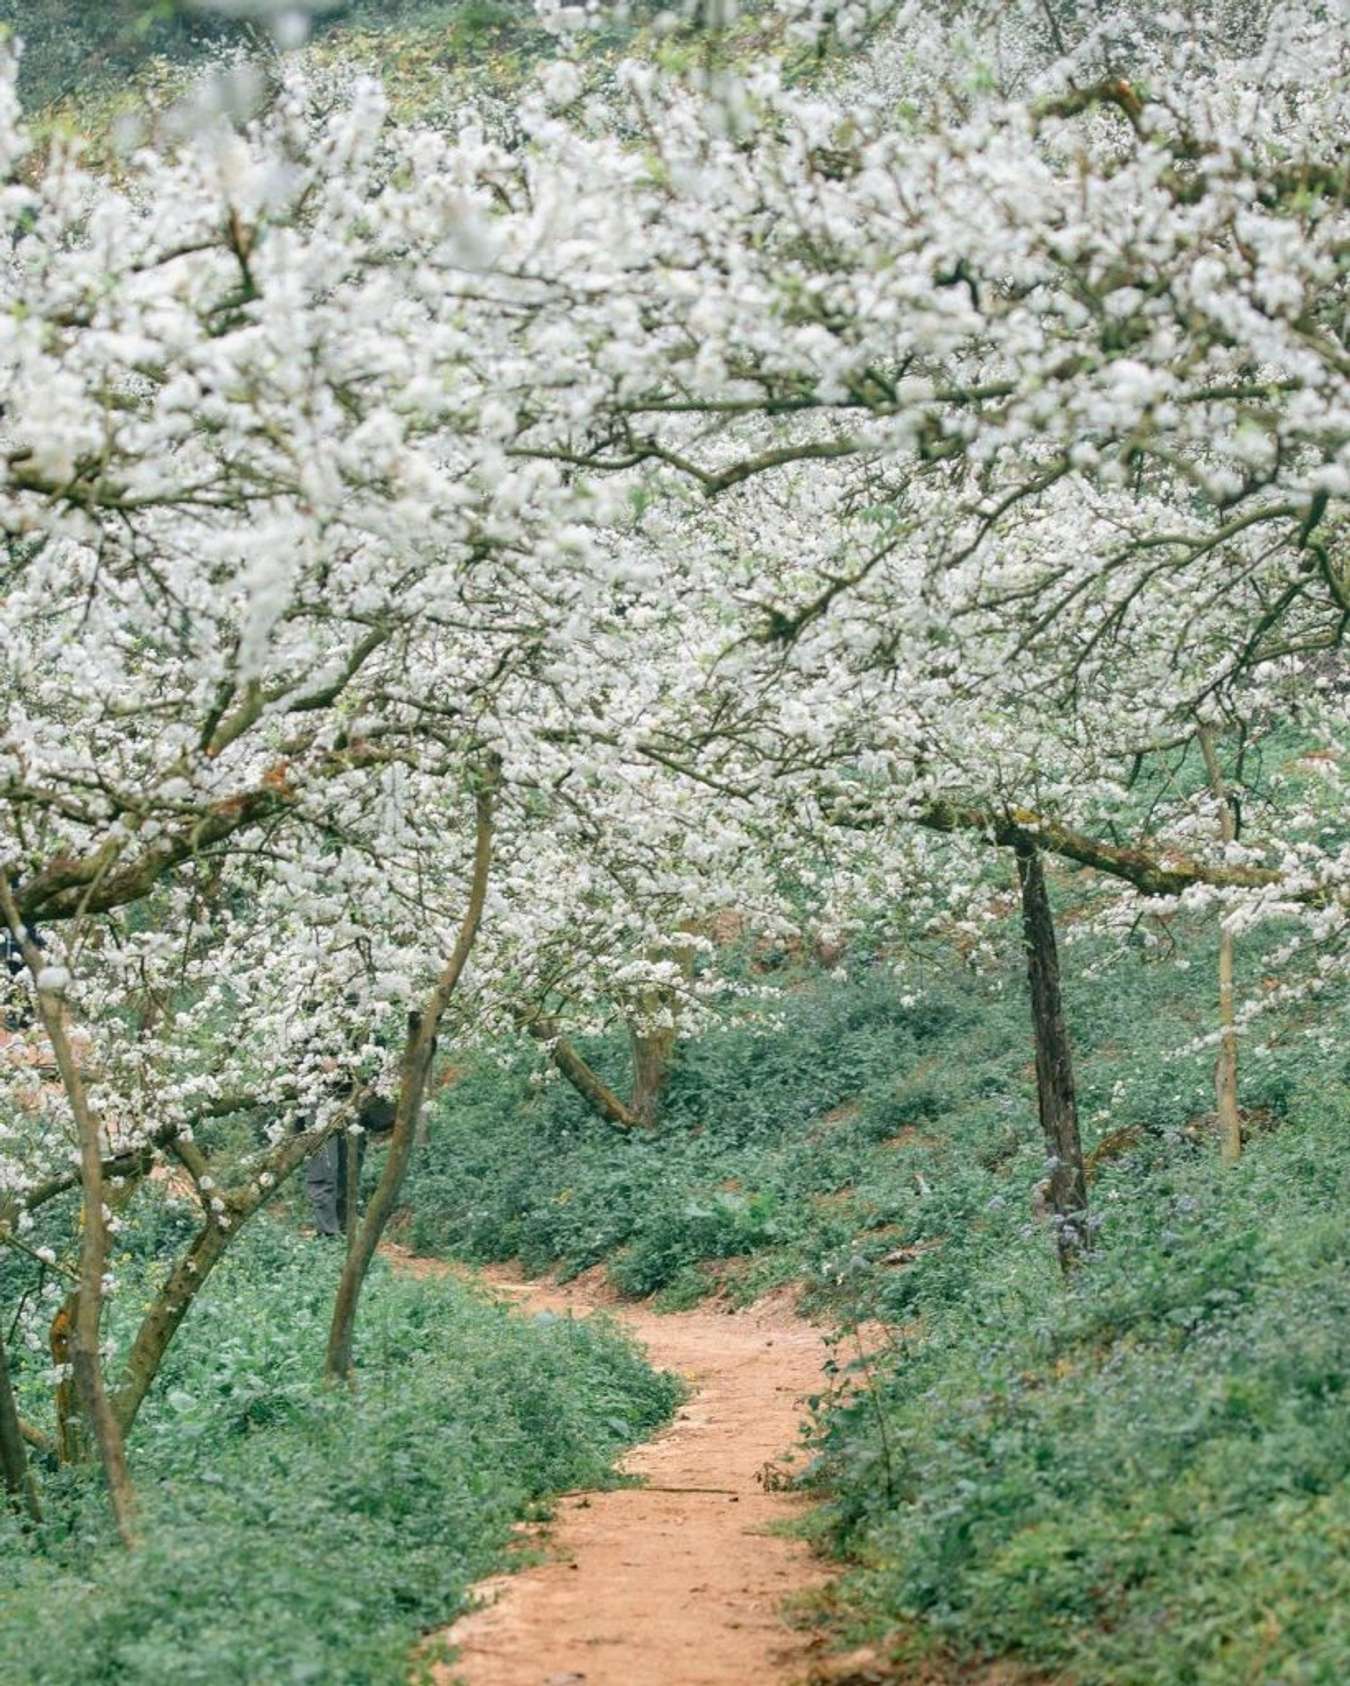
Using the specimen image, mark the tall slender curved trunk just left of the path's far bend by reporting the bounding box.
[324,764,499,1381]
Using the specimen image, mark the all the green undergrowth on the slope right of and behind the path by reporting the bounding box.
[410,929,1350,1686]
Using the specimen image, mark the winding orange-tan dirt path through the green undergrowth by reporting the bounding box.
[406,1271,828,1686]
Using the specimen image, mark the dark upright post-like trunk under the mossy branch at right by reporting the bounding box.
[1016,843,1089,1273]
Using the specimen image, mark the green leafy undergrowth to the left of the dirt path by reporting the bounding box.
[0,1224,678,1686]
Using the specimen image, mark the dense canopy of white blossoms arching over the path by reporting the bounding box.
[0,3,1350,1227]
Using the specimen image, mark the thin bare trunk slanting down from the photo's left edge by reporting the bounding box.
[0,873,135,1546]
